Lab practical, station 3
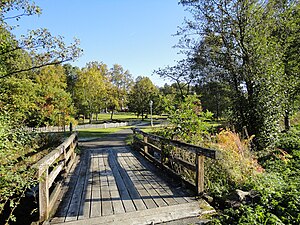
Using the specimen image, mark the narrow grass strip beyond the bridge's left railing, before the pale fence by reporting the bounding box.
[77,126,130,138]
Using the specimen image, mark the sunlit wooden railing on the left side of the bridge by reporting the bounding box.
[34,133,78,221]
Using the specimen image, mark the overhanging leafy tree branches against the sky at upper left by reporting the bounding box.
[0,0,82,79]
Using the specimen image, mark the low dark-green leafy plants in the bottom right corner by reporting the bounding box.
[211,127,300,225]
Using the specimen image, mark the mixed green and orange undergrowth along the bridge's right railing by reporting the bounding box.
[158,96,300,225]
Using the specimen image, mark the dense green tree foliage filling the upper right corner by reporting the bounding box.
[178,0,300,150]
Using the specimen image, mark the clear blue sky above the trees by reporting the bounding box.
[9,0,187,86]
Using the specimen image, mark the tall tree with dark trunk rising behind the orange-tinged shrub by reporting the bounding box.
[179,0,298,149]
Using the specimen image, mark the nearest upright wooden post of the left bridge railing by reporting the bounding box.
[39,168,49,221]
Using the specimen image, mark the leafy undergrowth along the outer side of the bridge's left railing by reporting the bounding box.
[0,115,62,224]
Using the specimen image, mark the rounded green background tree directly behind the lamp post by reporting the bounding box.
[128,76,158,120]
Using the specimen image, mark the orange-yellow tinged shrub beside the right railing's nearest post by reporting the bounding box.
[205,129,263,197]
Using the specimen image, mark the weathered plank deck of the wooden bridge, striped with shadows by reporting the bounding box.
[50,146,210,225]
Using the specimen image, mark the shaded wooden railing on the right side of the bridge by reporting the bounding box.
[132,128,217,194]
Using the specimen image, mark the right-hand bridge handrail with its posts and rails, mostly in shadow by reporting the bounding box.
[132,128,217,194]
